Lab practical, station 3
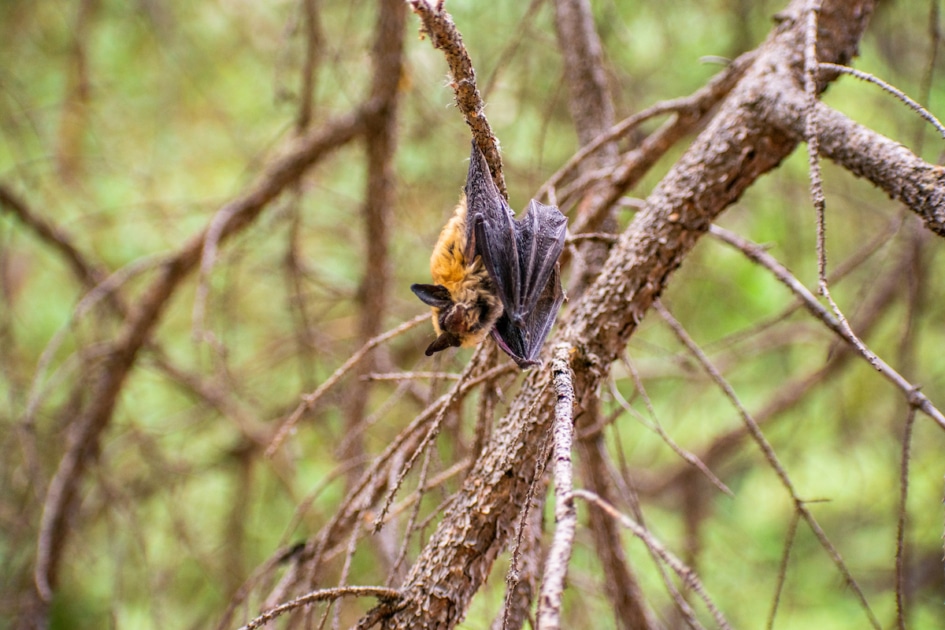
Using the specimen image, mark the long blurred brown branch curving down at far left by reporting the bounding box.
[34,103,375,602]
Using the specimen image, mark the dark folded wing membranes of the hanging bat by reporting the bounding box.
[466,144,568,367]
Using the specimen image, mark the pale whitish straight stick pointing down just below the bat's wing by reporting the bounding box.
[538,343,577,630]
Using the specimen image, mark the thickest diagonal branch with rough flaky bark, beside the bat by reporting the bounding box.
[374,0,873,628]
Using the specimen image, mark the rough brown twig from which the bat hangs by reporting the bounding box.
[408,0,509,199]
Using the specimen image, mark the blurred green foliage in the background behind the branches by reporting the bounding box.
[0,0,945,629]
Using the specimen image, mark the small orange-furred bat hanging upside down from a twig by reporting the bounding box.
[410,141,568,369]
